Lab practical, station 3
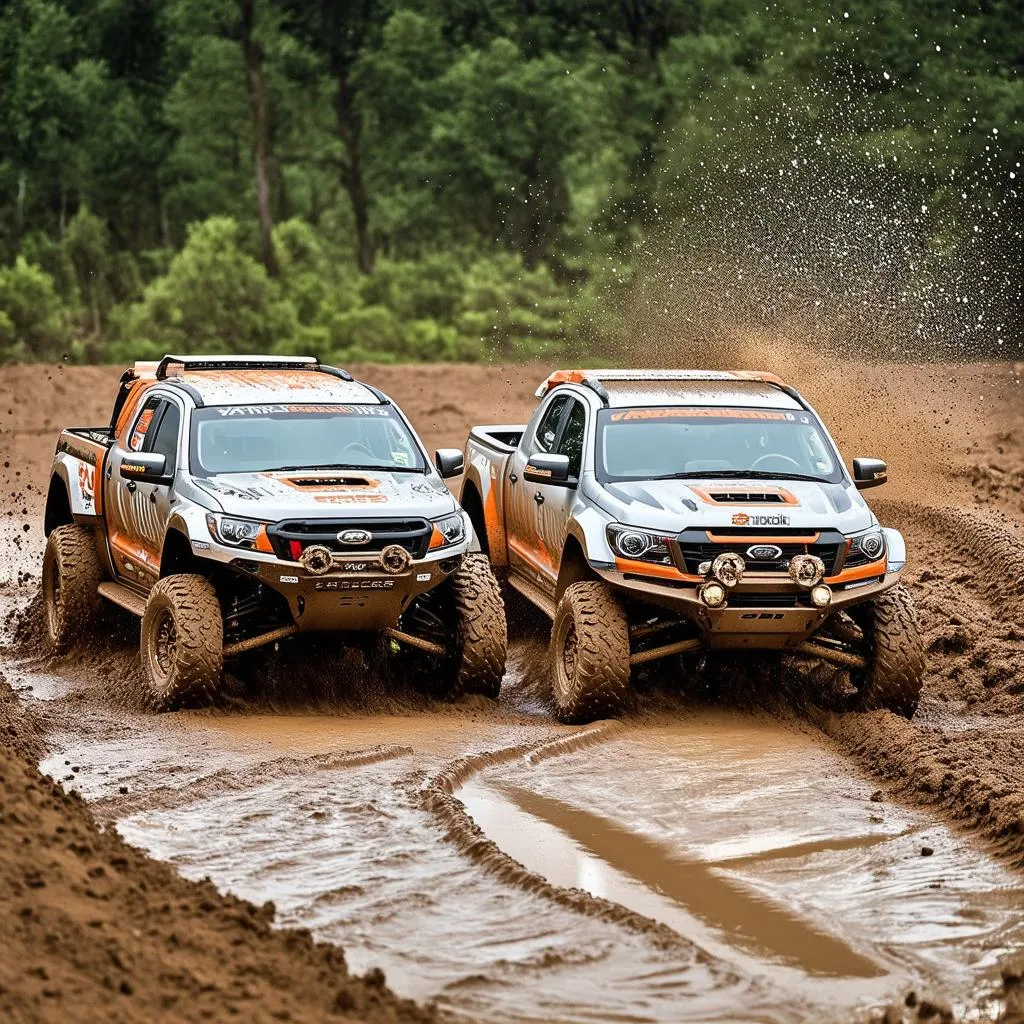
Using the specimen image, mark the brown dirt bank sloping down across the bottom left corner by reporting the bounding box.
[0,682,437,1024]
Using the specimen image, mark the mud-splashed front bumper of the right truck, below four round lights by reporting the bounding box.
[594,566,902,649]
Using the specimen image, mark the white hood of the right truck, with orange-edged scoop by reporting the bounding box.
[585,478,876,534]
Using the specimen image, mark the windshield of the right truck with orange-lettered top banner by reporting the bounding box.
[596,407,843,483]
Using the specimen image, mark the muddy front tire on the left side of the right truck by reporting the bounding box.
[551,583,631,723]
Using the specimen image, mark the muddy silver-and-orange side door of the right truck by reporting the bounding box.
[505,394,572,588]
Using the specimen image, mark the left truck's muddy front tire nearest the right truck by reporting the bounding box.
[447,554,508,700]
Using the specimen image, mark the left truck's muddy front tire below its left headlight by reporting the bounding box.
[141,573,224,711]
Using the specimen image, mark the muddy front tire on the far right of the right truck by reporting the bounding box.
[853,584,925,718]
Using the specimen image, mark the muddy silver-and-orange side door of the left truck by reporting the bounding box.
[104,395,181,588]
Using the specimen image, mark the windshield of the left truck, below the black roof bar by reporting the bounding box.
[190,406,425,476]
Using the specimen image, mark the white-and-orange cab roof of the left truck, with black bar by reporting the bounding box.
[129,355,387,406]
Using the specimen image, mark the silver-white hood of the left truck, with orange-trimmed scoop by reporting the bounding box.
[193,470,457,522]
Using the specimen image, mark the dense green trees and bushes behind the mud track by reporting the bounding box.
[0,0,1024,360]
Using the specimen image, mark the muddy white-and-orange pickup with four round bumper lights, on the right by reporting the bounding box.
[462,370,924,722]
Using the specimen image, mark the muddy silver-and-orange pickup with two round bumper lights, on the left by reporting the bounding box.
[43,355,506,709]
